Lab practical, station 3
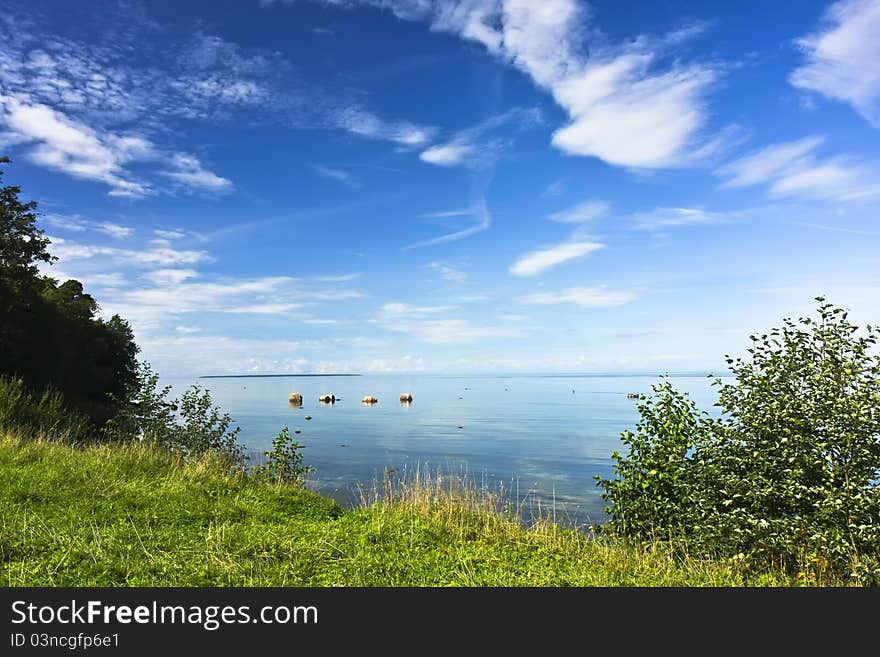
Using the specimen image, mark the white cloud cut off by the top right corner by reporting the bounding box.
[789,0,880,128]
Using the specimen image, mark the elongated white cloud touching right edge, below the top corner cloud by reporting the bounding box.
[716,137,880,201]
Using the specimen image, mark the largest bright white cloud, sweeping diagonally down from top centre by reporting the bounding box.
[326,0,717,168]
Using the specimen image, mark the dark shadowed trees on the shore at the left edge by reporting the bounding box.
[0,158,138,426]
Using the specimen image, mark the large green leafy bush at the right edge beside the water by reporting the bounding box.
[597,297,880,583]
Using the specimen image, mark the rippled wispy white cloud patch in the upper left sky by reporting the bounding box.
[0,14,264,198]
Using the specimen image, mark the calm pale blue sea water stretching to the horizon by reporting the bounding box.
[164,375,717,526]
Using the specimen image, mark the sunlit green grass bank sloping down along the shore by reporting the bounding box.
[0,435,801,587]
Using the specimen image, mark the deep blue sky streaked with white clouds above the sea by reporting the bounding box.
[0,0,880,376]
